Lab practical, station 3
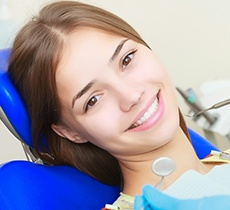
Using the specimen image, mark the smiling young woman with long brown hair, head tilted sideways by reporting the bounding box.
[8,1,229,209]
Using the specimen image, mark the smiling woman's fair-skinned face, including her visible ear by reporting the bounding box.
[52,28,179,158]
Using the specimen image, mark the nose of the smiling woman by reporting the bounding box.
[117,81,144,112]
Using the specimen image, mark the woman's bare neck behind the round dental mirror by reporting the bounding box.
[120,129,209,196]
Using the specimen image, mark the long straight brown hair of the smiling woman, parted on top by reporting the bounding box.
[8,1,190,186]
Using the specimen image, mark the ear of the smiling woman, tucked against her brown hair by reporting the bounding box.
[51,124,88,143]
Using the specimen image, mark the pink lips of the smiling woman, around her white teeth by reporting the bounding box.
[127,90,164,131]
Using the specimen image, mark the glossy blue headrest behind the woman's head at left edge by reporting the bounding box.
[0,49,33,147]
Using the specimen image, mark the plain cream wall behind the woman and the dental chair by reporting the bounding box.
[0,0,230,162]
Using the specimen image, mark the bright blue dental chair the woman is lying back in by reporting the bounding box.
[0,49,218,210]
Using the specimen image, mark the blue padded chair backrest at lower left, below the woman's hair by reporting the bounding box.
[0,161,119,210]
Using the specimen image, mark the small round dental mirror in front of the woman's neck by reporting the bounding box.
[152,157,176,189]
